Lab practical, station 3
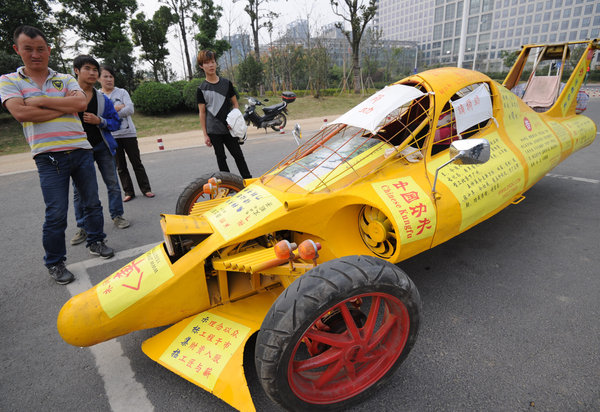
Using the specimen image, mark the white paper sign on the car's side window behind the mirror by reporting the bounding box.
[450,84,493,134]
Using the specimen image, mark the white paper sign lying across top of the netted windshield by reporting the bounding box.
[332,84,425,134]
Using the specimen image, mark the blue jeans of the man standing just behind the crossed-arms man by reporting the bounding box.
[73,142,123,227]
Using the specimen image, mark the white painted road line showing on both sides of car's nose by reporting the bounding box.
[67,243,157,412]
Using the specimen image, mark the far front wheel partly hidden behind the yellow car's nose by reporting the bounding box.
[175,172,244,215]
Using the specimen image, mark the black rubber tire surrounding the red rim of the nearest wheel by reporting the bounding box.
[255,256,421,411]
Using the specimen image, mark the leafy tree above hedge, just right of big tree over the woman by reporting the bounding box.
[130,6,177,81]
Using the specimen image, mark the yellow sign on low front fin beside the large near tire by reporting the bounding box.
[159,312,250,392]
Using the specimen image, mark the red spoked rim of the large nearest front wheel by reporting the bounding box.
[288,292,410,404]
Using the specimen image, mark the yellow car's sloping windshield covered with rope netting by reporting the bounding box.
[261,86,431,193]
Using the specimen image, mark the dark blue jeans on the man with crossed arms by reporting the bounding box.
[34,149,106,266]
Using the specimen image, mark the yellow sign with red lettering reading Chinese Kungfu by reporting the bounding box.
[373,176,436,244]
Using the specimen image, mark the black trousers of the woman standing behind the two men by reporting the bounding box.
[115,137,152,197]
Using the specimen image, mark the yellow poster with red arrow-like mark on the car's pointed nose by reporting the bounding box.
[96,244,173,318]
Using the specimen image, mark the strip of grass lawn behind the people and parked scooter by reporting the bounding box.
[0,90,374,155]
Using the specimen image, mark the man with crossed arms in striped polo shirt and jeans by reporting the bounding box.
[0,26,114,285]
